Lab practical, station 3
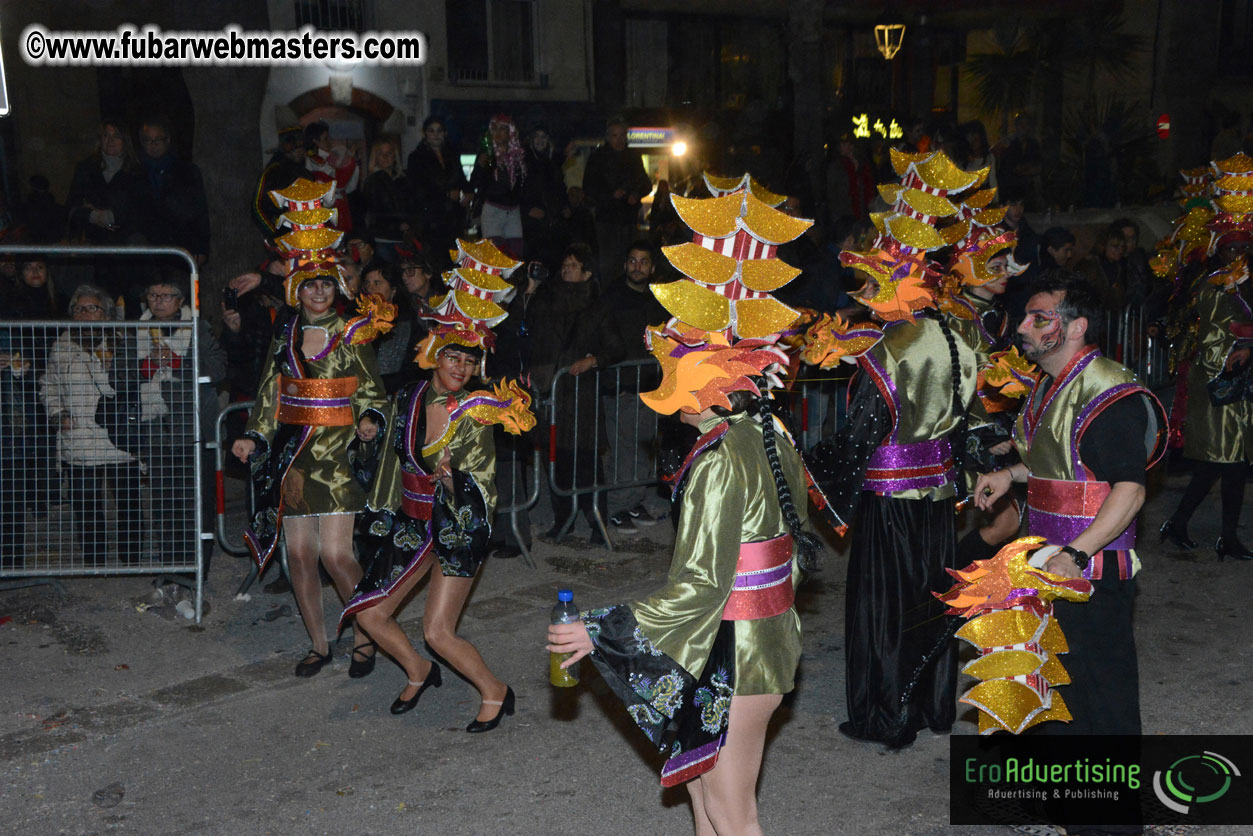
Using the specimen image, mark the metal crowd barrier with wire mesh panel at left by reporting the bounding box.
[0,246,212,622]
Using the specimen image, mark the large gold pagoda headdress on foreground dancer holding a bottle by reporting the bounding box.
[640,184,813,415]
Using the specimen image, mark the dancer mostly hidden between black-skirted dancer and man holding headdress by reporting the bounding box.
[940,209,1026,565]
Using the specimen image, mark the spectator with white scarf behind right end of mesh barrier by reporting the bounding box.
[135,271,227,573]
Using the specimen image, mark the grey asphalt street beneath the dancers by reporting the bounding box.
[0,463,1253,836]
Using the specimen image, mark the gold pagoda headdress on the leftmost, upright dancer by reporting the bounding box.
[269,178,352,307]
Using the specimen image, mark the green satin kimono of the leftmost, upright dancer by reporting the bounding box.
[247,310,386,516]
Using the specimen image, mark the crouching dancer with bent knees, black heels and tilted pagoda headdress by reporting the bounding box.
[342,241,535,733]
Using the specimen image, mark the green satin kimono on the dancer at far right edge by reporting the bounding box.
[1183,283,1253,462]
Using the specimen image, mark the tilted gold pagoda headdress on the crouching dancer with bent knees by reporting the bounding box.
[416,238,521,368]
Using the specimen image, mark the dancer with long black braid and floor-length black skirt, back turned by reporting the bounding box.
[804,150,990,747]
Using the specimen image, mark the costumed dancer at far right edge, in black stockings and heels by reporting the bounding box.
[1162,154,1253,560]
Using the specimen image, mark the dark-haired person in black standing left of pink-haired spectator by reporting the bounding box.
[406,117,474,269]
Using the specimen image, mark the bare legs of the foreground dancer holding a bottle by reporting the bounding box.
[689,694,783,836]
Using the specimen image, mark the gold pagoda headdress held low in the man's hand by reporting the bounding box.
[933,536,1093,734]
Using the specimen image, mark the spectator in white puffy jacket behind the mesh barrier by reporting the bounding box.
[41,285,145,567]
